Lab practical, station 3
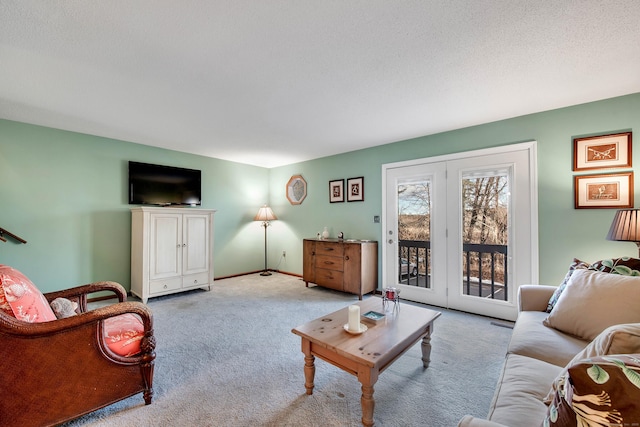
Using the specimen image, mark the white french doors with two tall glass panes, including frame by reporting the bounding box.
[382,142,538,320]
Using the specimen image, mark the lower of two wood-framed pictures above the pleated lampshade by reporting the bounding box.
[574,172,633,209]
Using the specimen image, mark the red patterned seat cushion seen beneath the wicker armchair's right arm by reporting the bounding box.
[104,313,144,357]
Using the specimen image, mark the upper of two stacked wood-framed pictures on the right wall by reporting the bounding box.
[573,132,631,171]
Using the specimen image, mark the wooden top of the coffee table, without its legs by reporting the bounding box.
[291,296,441,371]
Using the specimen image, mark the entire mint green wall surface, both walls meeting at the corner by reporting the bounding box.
[0,94,640,291]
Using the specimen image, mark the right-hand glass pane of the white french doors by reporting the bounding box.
[462,170,509,301]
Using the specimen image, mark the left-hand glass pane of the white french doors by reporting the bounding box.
[396,179,432,288]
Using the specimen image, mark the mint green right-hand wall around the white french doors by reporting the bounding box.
[270,94,640,284]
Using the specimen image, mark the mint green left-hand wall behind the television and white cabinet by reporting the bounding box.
[0,120,269,291]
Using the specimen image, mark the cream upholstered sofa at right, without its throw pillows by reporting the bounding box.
[458,270,640,427]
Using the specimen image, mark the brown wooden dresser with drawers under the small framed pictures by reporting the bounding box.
[302,239,378,299]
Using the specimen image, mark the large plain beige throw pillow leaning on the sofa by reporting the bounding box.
[543,270,640,341]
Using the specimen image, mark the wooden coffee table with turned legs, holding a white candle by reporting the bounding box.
[291,297,440,426]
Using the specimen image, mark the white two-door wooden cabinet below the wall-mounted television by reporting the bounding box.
[131,207,215,303]
